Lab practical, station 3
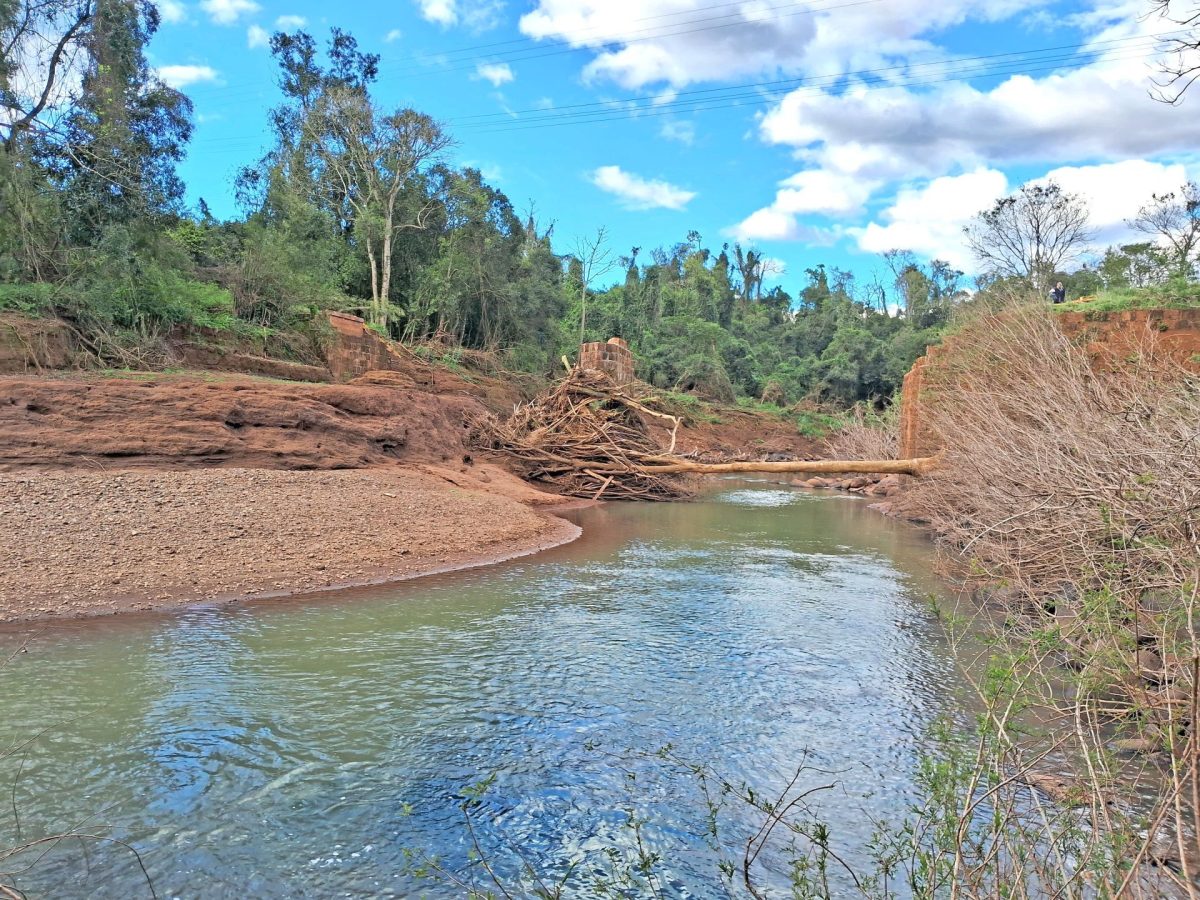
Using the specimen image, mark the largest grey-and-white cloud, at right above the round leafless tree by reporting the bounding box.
[736,6,1200,266]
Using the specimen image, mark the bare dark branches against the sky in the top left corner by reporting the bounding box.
[0,0,94,151]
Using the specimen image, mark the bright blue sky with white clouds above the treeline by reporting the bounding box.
[150,0,1200,289]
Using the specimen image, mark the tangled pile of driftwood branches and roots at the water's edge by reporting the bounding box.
[473,368,689,500]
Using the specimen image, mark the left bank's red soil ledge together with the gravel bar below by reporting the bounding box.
[0,376,577,622]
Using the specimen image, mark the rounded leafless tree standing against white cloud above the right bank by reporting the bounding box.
[962,181,1093,292]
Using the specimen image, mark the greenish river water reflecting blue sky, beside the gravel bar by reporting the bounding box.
[0,481,958,898]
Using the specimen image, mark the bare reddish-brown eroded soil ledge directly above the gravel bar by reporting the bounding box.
[0,376,484,470]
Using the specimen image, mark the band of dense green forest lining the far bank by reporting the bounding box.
[0,0,1196,406]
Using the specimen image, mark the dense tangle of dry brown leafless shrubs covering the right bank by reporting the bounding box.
[900,304,1200,896]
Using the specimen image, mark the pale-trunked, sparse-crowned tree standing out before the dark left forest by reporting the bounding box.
[307,86,450,325]
